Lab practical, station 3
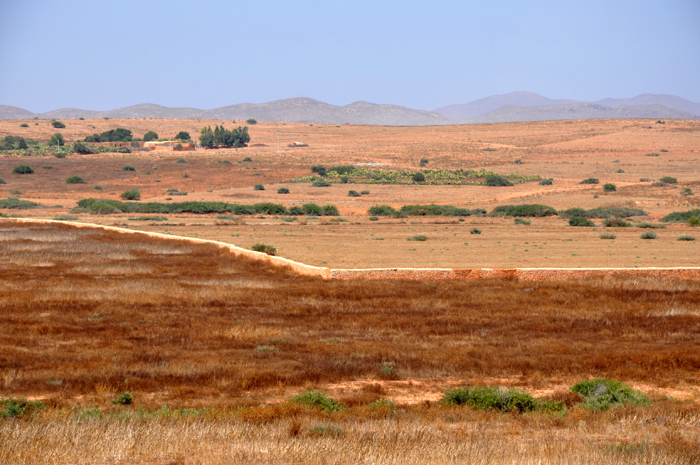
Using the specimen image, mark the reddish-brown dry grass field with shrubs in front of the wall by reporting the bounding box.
[0,221,700,464]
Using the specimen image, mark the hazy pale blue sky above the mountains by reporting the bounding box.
[0,0,700,112]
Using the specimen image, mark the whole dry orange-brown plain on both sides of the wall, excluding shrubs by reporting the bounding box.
[0,119,700,464]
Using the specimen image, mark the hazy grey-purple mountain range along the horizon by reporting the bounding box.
[0,92,700,126]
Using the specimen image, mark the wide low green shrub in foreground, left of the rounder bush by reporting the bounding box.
[441,386,538,413]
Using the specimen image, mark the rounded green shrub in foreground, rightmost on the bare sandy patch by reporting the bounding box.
[571,378,651,410]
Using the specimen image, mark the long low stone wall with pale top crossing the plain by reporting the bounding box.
[2,218,700,281]
